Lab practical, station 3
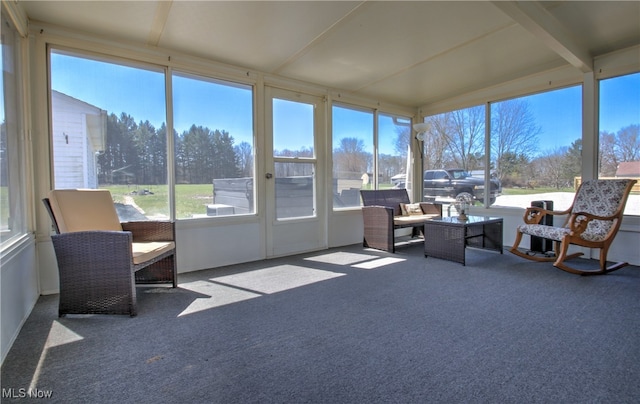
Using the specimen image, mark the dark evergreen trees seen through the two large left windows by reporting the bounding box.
[97,113,253,185]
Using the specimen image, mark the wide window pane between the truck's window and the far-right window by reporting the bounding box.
[491,86,582,210]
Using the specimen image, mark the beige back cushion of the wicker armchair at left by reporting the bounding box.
[49,189,122,233]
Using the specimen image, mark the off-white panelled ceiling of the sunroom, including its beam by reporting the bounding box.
[19,0,640,107]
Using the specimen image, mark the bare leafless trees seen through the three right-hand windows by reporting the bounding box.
[424,99,640,189]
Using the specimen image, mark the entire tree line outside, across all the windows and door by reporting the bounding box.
[92,104,640,189]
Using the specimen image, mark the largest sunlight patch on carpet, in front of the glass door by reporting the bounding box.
[211,265,345,294]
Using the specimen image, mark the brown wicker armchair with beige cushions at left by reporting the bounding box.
[43,189,177,317]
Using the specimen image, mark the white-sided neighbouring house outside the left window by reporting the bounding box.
[51,91,107,189]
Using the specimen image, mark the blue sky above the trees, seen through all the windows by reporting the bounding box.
[47,53,640,153]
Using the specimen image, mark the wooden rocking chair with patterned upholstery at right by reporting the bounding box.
[510,179,636,275]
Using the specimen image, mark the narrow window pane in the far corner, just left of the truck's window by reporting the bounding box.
[378,114,411,194]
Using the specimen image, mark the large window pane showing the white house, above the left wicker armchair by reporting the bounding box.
[51,50,169,221]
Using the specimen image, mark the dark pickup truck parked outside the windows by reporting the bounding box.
[423,168,502,205]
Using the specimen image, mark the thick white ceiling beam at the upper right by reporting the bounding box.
[492,1,593,73]
